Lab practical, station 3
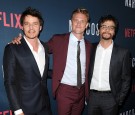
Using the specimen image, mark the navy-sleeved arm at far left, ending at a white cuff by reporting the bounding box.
[3,45,20,111]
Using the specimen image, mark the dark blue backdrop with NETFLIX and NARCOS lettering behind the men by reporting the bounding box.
[0,0,135,115]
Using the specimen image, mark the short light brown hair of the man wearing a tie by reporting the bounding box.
[71,8,90,22]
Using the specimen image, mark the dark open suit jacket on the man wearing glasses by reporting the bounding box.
[89,43,131,105]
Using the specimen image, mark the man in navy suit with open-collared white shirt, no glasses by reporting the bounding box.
[3,7,51,115]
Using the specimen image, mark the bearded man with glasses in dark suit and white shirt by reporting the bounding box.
[88,15,130,115]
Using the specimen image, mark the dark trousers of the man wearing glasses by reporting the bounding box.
[88,91,118,115]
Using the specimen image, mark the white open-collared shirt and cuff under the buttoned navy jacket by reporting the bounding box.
[14,36,45,115]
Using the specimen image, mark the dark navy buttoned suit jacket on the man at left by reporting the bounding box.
[3,39,50,113]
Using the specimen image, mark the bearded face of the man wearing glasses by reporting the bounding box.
[99,20,115,40]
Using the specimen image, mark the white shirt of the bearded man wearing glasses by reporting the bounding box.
[90,42,113,91]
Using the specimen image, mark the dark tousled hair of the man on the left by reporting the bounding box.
[20,7,44,26]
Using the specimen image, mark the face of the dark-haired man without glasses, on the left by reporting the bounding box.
[22,15,42,39]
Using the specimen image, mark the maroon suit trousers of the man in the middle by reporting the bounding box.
[56,84,85,115]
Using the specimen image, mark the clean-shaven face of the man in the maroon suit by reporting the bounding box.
[71,13,88,35]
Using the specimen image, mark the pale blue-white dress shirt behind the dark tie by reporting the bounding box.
[61,33,86,86]
